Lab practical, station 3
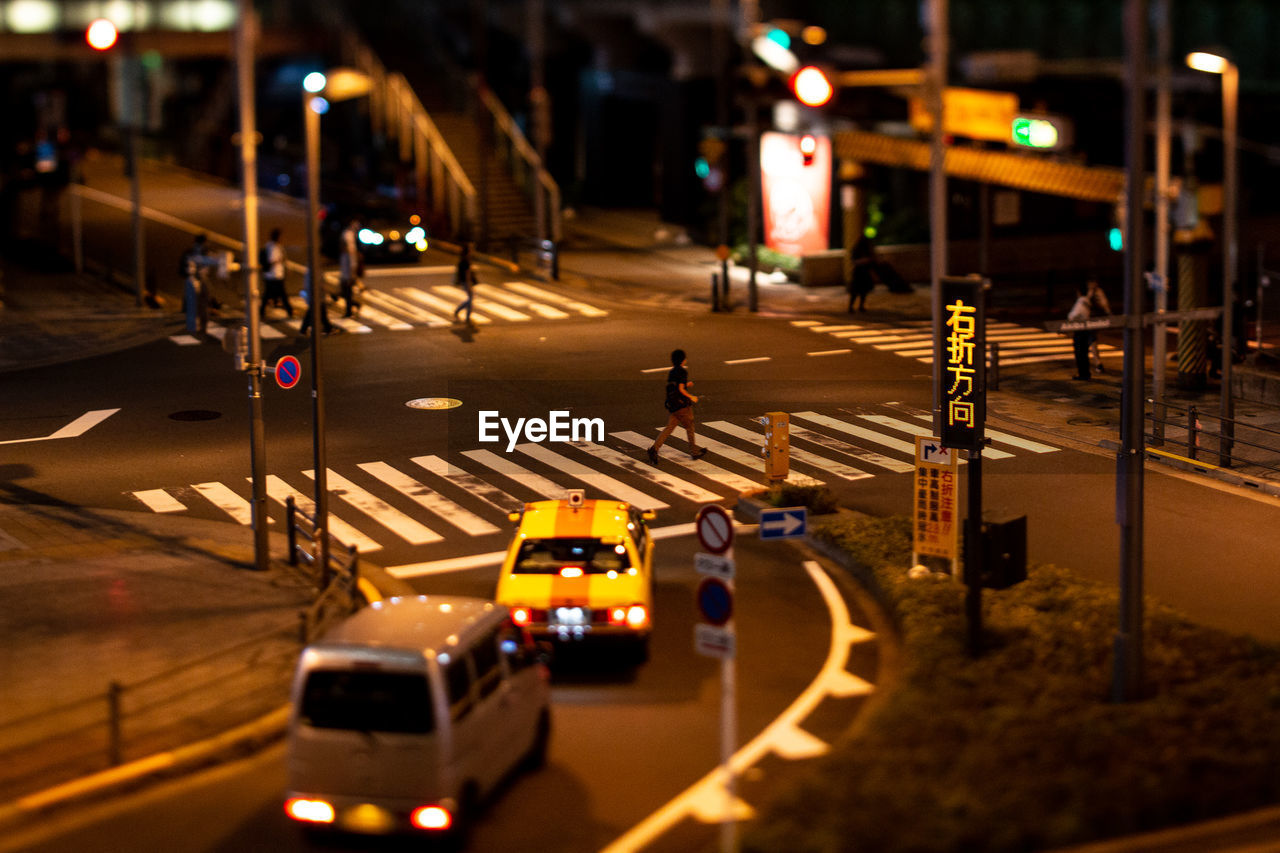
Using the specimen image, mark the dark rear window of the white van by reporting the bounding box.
[298,670,435,734]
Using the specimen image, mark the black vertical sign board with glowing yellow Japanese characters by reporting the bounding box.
[934,275,987,451]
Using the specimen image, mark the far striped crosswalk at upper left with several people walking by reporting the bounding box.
[169,280,609,346]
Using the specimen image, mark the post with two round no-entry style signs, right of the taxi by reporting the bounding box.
[694,503,737,853]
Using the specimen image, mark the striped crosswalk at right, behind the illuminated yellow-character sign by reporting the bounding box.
[791,320,1124,366]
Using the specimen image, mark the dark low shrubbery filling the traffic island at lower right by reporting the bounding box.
[744,517,1280,853]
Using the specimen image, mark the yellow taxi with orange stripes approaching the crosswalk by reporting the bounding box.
[494,491,654,661]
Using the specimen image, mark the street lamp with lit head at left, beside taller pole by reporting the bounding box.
[302,68,372,587]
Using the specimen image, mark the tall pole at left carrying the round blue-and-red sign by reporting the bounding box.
[236,0,270,571]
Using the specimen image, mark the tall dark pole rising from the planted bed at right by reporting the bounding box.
[1112,0,1147,702]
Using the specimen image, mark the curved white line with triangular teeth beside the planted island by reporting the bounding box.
[602,560,874,853]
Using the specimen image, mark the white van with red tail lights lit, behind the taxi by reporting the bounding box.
[284,596,550,839]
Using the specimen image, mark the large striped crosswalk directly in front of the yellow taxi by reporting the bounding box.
[127,403,1059,553]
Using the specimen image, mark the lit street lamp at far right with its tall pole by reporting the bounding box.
[1187,51,1240,466]
